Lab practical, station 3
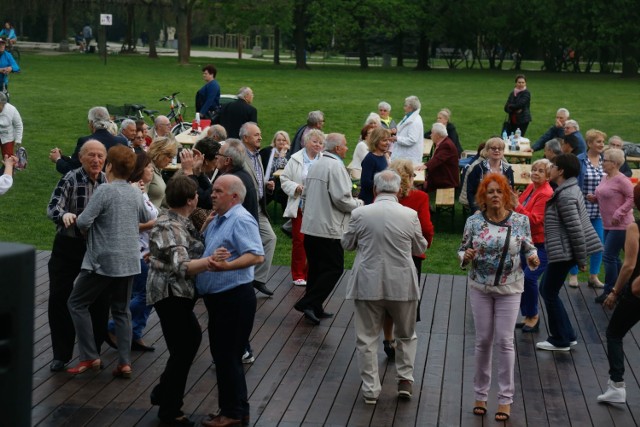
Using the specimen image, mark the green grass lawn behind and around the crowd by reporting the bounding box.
[0,52,640,274]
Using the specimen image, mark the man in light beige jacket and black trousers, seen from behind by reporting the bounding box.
[294,133,364,325]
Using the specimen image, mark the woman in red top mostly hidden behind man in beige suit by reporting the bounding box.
[382,159,434,360]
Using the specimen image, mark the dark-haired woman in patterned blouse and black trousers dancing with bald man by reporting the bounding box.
[147,175,213,425]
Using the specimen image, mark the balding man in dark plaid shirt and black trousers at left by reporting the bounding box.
[47,139,109,372]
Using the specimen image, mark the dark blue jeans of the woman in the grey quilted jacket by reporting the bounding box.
[540,260,576,347]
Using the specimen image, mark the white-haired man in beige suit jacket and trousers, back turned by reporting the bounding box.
[341,171,428,405]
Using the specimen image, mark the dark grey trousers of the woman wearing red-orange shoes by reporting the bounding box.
[67,270,133,365]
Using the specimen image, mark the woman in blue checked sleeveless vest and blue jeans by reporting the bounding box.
[569,129,607,288]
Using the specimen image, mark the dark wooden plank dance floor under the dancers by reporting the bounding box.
[32,251,640,427]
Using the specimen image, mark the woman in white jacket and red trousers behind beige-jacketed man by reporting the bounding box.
[280,129,324,286]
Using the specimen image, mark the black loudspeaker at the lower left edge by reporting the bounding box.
[0,243,36,426]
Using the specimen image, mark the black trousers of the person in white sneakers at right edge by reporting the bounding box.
[607,285,640,382]
